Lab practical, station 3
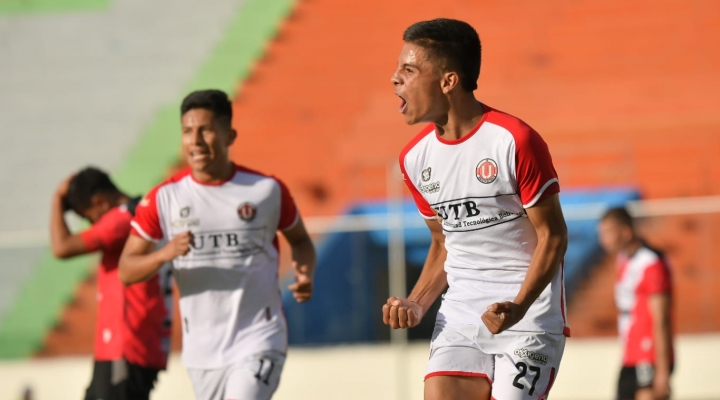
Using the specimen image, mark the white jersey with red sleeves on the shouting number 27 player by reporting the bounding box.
[400,105,569,334]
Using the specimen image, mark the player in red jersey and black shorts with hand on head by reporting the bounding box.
[50,168,172,400]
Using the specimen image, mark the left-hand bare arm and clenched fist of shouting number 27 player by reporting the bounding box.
[383,219,447,329]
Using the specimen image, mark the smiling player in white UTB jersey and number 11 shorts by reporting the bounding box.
[120,90,315,400]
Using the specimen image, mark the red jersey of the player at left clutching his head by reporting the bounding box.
[80,205,171,369]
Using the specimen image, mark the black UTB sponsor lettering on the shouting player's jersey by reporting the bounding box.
[431,197,525,232]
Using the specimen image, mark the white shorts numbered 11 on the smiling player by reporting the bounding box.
[188,352,285,400]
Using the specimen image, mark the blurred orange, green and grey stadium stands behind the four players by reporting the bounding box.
[0,0,720,400]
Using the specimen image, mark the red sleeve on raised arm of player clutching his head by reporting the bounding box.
[80,208,131,252]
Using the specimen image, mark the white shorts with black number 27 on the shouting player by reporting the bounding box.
[425,324,565,400]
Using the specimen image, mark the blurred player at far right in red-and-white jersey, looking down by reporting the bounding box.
[598,207,674,400]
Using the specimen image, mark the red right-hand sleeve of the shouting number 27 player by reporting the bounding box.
[514,127,560,208]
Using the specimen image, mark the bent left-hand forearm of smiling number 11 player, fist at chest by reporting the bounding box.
[118,231,193,285]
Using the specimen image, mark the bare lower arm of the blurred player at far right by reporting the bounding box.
[648,293,672,399]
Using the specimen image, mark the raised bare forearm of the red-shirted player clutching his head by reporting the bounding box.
[50,176,92,258]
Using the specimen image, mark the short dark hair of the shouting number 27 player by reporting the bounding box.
[403,18,482,92]
